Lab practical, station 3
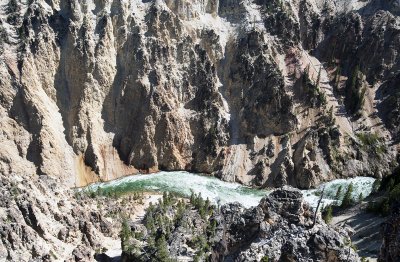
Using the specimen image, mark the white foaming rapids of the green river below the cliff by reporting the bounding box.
[83,172,375,208]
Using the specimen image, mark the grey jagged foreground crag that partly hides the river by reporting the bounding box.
[214,189,358,261]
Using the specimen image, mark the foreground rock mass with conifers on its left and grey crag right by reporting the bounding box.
[122,188,359,261]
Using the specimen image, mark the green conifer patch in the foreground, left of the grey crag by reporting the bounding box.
[121,193,217,261]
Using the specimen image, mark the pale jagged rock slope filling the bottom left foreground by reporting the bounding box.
[0,171,119,261]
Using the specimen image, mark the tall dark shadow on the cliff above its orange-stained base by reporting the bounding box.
[101,29,155,169]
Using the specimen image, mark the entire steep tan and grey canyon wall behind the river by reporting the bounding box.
[0,0,400,188]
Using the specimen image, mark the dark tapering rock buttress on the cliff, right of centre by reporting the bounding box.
[222,31,296,139]
